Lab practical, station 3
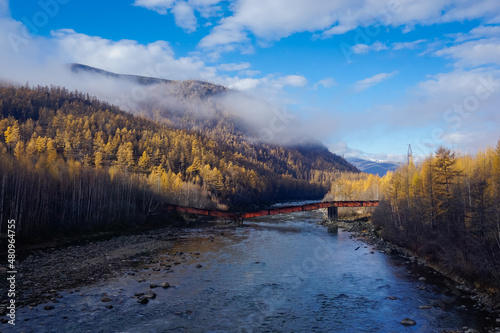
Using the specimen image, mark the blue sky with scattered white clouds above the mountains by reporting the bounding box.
[0,0,500,160]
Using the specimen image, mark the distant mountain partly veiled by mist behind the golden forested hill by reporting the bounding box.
[70,64,359,178]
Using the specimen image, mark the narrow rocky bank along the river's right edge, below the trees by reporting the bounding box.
[323,218,500,333]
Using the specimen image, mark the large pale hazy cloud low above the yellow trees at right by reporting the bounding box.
[332,66,500,158]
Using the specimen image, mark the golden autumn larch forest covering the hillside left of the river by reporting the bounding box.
[0,86,356,237]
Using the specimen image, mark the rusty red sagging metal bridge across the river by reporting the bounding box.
[165,201,378,221]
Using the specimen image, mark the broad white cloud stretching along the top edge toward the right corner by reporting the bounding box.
[199,0,500,52]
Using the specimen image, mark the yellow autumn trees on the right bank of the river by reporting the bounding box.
[330,141,500,292]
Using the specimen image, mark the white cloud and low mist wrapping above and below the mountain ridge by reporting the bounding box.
[0,12,326,147]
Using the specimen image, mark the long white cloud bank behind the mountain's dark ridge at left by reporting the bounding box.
[0,13,307,109]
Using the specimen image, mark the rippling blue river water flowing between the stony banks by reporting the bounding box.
[15,211,492,333]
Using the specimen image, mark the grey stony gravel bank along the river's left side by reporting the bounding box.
[0,217,230,312]
